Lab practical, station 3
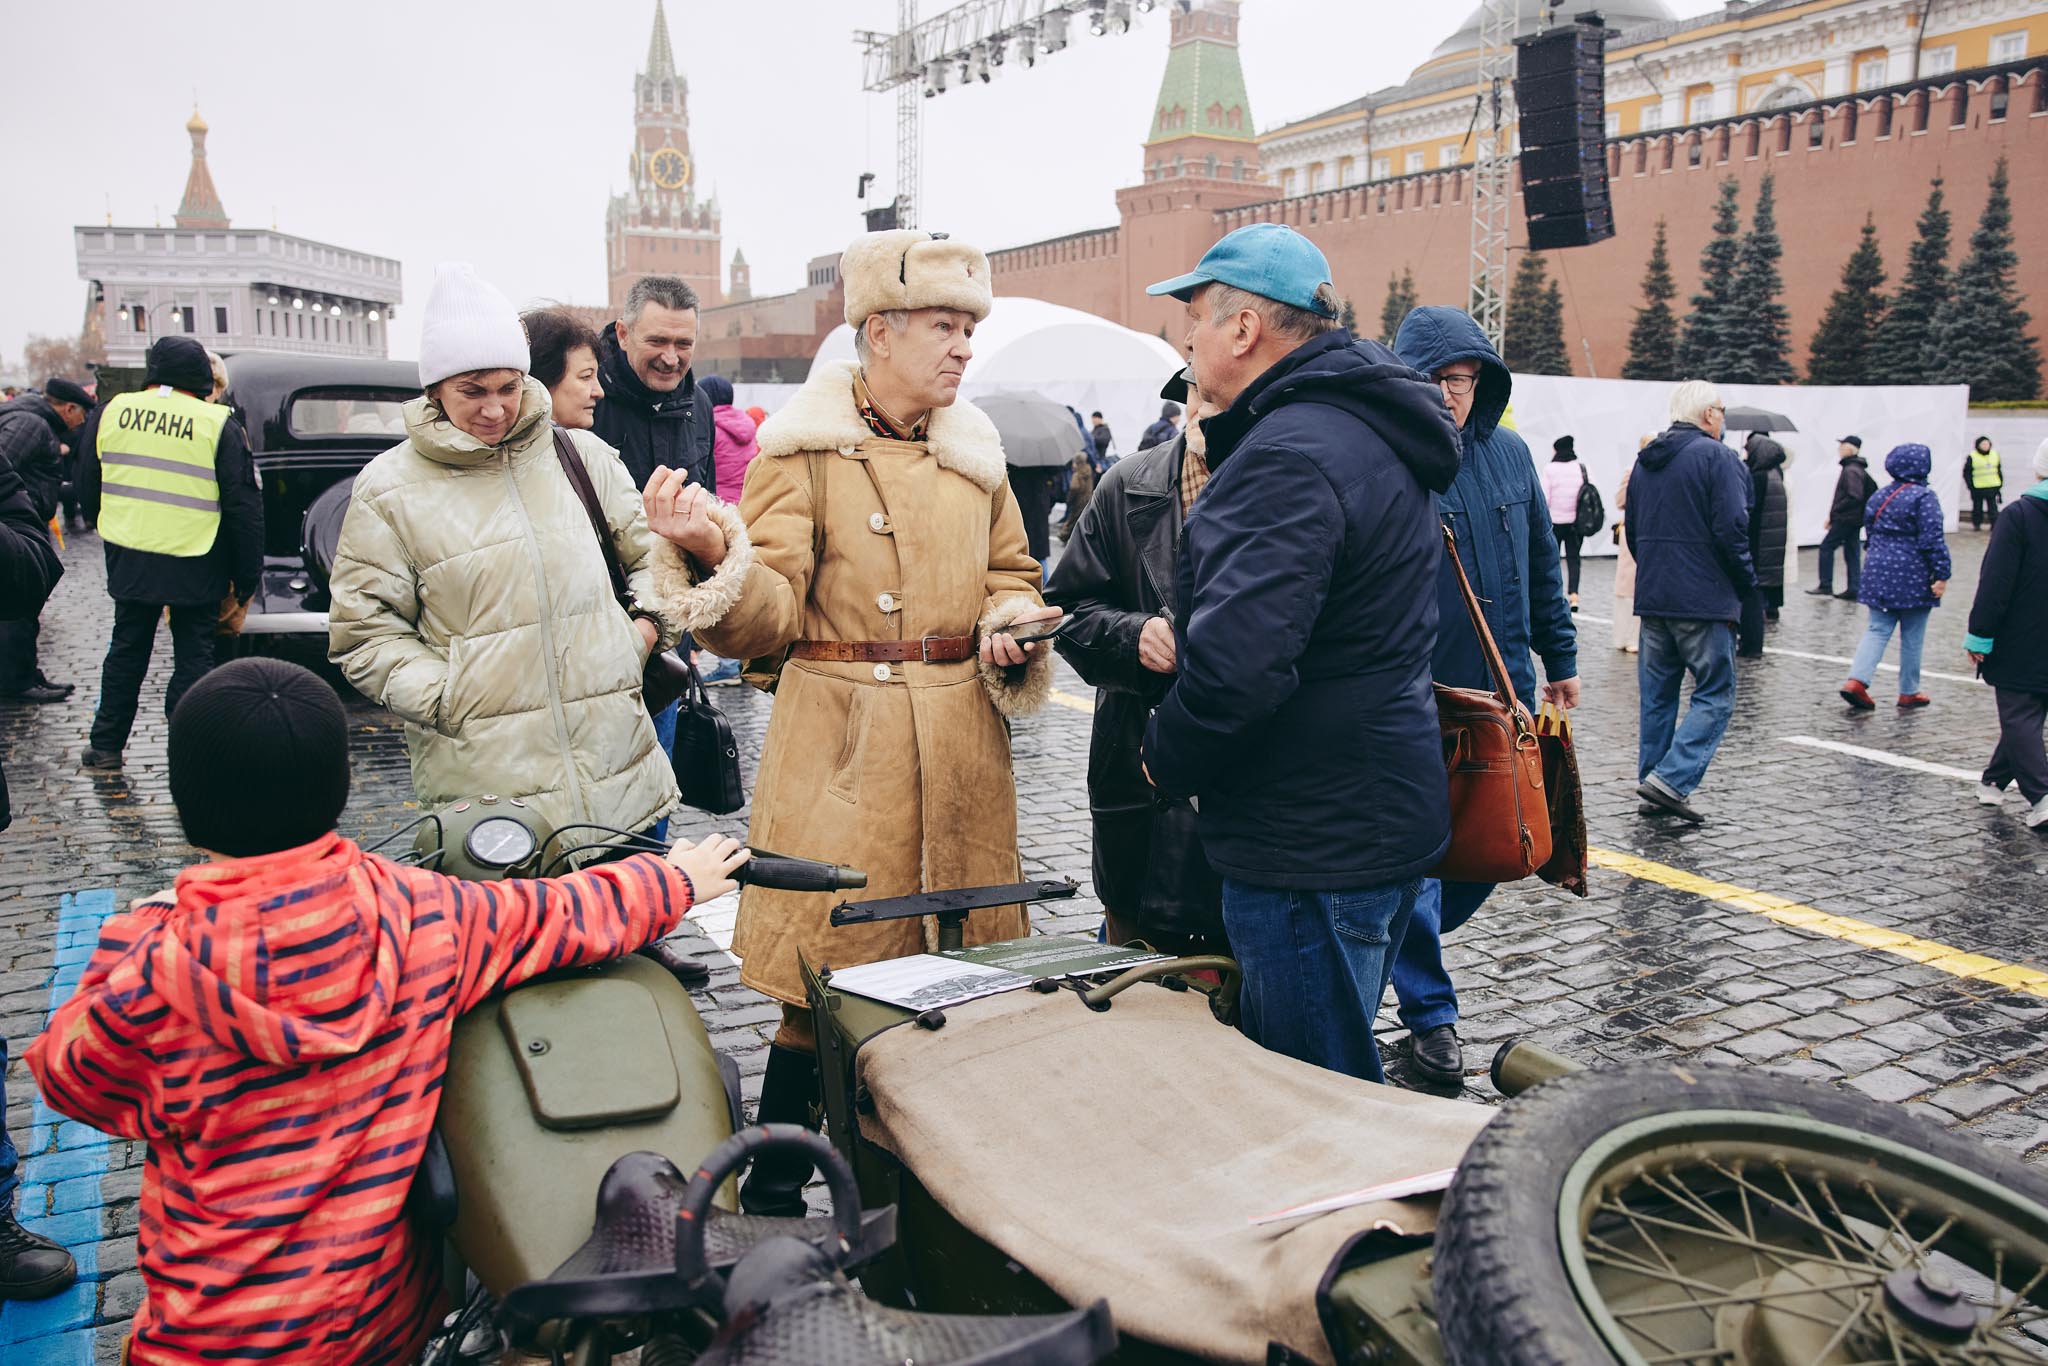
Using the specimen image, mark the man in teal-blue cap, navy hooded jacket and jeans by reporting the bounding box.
[1145,223,1458,1081]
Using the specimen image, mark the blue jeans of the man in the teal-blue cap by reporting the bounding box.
[1223,879,1421,1081]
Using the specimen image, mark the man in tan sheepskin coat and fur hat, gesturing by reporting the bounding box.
[647,229,1059,1214]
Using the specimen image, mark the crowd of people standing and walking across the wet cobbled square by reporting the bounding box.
[0,223,2048,1362]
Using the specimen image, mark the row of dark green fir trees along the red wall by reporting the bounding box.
[1380,158,2042,403]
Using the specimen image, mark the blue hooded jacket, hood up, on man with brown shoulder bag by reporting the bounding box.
[1395,307,1579,711]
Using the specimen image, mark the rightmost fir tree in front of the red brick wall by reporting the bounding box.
[1927,156,2042,403]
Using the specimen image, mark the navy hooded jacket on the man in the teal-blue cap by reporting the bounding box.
[1145,330,1458,891]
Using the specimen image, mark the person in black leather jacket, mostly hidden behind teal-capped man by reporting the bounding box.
[1044,371,1229,954]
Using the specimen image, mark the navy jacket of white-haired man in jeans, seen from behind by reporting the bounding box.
[1622,422,1757,623]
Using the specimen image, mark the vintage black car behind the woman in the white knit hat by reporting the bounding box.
[223,352,420,653]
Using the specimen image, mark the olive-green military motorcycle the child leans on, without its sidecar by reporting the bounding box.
[380,797,1114,1366]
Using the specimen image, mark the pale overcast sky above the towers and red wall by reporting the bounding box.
[0,0,1718,362]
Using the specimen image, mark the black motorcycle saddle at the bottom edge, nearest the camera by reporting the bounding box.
[696,1237,1116,1366]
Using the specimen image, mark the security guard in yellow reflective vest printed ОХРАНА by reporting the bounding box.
[78,336,262,768]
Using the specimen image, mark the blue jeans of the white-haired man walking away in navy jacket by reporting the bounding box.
[1636,616,1735,797]
